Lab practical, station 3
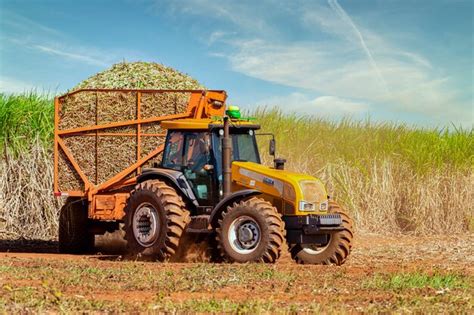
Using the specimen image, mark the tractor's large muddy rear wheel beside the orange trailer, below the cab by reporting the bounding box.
[124,180,190,261]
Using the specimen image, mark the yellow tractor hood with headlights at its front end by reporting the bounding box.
[232,161,328,215]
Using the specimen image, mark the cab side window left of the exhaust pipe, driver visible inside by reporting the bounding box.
[162,131,214,206]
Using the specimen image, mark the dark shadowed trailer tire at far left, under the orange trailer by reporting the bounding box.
[58,198,94,254]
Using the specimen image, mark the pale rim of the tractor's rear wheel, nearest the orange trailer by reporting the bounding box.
[132,203,159,247]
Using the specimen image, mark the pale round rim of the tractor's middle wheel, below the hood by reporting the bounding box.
[228,216,262,254]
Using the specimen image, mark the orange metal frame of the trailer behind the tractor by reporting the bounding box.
[54,89,227,221]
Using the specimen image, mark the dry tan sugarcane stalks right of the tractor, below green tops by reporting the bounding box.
[318,161,474,234]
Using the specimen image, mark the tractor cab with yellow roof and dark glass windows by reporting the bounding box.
[161,119,260,207]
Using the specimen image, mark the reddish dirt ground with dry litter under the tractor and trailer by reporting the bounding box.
[0,233,474,312]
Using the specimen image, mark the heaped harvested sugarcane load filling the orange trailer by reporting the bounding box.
[57,62,211,191]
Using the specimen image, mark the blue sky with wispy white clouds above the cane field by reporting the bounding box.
[0,0,474,127]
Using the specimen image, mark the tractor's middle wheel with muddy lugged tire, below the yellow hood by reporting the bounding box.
[216,197,285,263]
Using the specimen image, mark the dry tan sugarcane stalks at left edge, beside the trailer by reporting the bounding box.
[0,141,60,239]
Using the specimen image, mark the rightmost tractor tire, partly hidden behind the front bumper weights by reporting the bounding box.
[290,201,354,266]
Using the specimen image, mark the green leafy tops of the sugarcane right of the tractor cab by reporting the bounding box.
[253,109,474,173]
